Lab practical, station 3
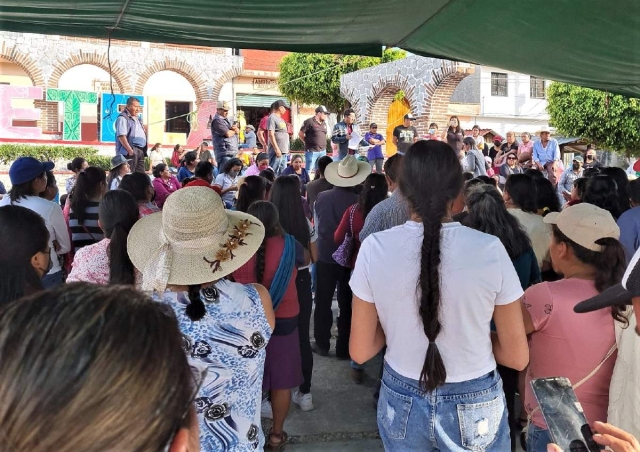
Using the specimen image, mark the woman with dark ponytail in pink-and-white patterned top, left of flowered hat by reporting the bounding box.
[67,190,139,285]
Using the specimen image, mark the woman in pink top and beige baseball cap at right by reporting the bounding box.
[522,203,627,452]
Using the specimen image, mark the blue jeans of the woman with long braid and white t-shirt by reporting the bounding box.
[378,363,511,452]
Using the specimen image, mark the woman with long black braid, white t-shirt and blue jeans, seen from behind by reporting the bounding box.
[350,140,529,452]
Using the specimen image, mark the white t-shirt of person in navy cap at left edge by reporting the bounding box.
[0,195,71,275]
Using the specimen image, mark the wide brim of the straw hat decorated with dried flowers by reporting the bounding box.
[127,210,264,286]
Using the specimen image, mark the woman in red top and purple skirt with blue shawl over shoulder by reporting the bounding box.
[233,202,309,450]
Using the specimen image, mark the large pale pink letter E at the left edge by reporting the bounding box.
[0,85,45,139]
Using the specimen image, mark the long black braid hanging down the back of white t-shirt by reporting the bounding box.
[418,200,447,391]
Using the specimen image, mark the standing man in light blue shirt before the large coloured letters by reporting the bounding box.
[116,97,147,173]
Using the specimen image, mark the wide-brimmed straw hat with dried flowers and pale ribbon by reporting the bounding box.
[127,187,264,291]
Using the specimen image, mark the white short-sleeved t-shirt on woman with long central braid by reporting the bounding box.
[350,221,523,383]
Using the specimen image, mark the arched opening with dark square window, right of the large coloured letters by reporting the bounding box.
[142,70,197,145]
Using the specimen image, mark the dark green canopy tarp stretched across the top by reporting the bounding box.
[0,0,640,97]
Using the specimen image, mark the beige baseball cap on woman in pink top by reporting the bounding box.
[544,202,620,251]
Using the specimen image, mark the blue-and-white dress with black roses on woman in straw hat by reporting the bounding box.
[154,280,272,452]
